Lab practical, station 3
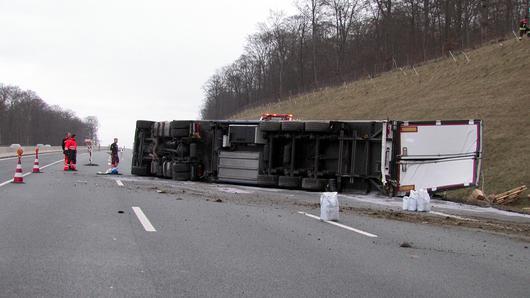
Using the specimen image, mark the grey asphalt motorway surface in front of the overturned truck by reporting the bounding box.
[0,152,530,297]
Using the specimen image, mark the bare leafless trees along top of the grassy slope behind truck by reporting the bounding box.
[201,0,530,119]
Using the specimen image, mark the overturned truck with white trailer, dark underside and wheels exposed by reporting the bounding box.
[131,120,482,195]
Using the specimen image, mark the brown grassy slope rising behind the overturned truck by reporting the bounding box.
[233,40,530,199]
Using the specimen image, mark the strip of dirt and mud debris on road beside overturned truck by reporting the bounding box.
[122,178,530,241]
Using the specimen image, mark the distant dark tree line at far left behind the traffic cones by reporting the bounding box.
[0,84,98,146]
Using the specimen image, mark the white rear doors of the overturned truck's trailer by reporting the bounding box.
[397,120,482,192]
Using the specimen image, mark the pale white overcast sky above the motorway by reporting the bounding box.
[0,0,295,146]
